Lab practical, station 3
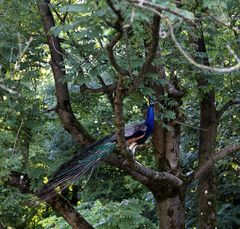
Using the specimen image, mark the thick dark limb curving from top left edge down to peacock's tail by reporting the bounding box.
[38,0,93,146]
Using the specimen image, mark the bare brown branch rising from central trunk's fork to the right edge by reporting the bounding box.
[187,144,240,184]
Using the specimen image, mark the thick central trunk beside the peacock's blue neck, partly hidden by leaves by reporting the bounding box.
[149,60,185,229]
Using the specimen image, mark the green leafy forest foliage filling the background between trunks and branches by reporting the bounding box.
[0,0,240,229]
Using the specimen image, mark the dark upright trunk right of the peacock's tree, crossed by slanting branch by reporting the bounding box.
[197,35,217,229]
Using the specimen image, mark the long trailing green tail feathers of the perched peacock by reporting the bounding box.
[37,139,116,200]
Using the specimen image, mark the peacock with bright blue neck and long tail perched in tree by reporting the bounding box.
[37,99,154,200]
